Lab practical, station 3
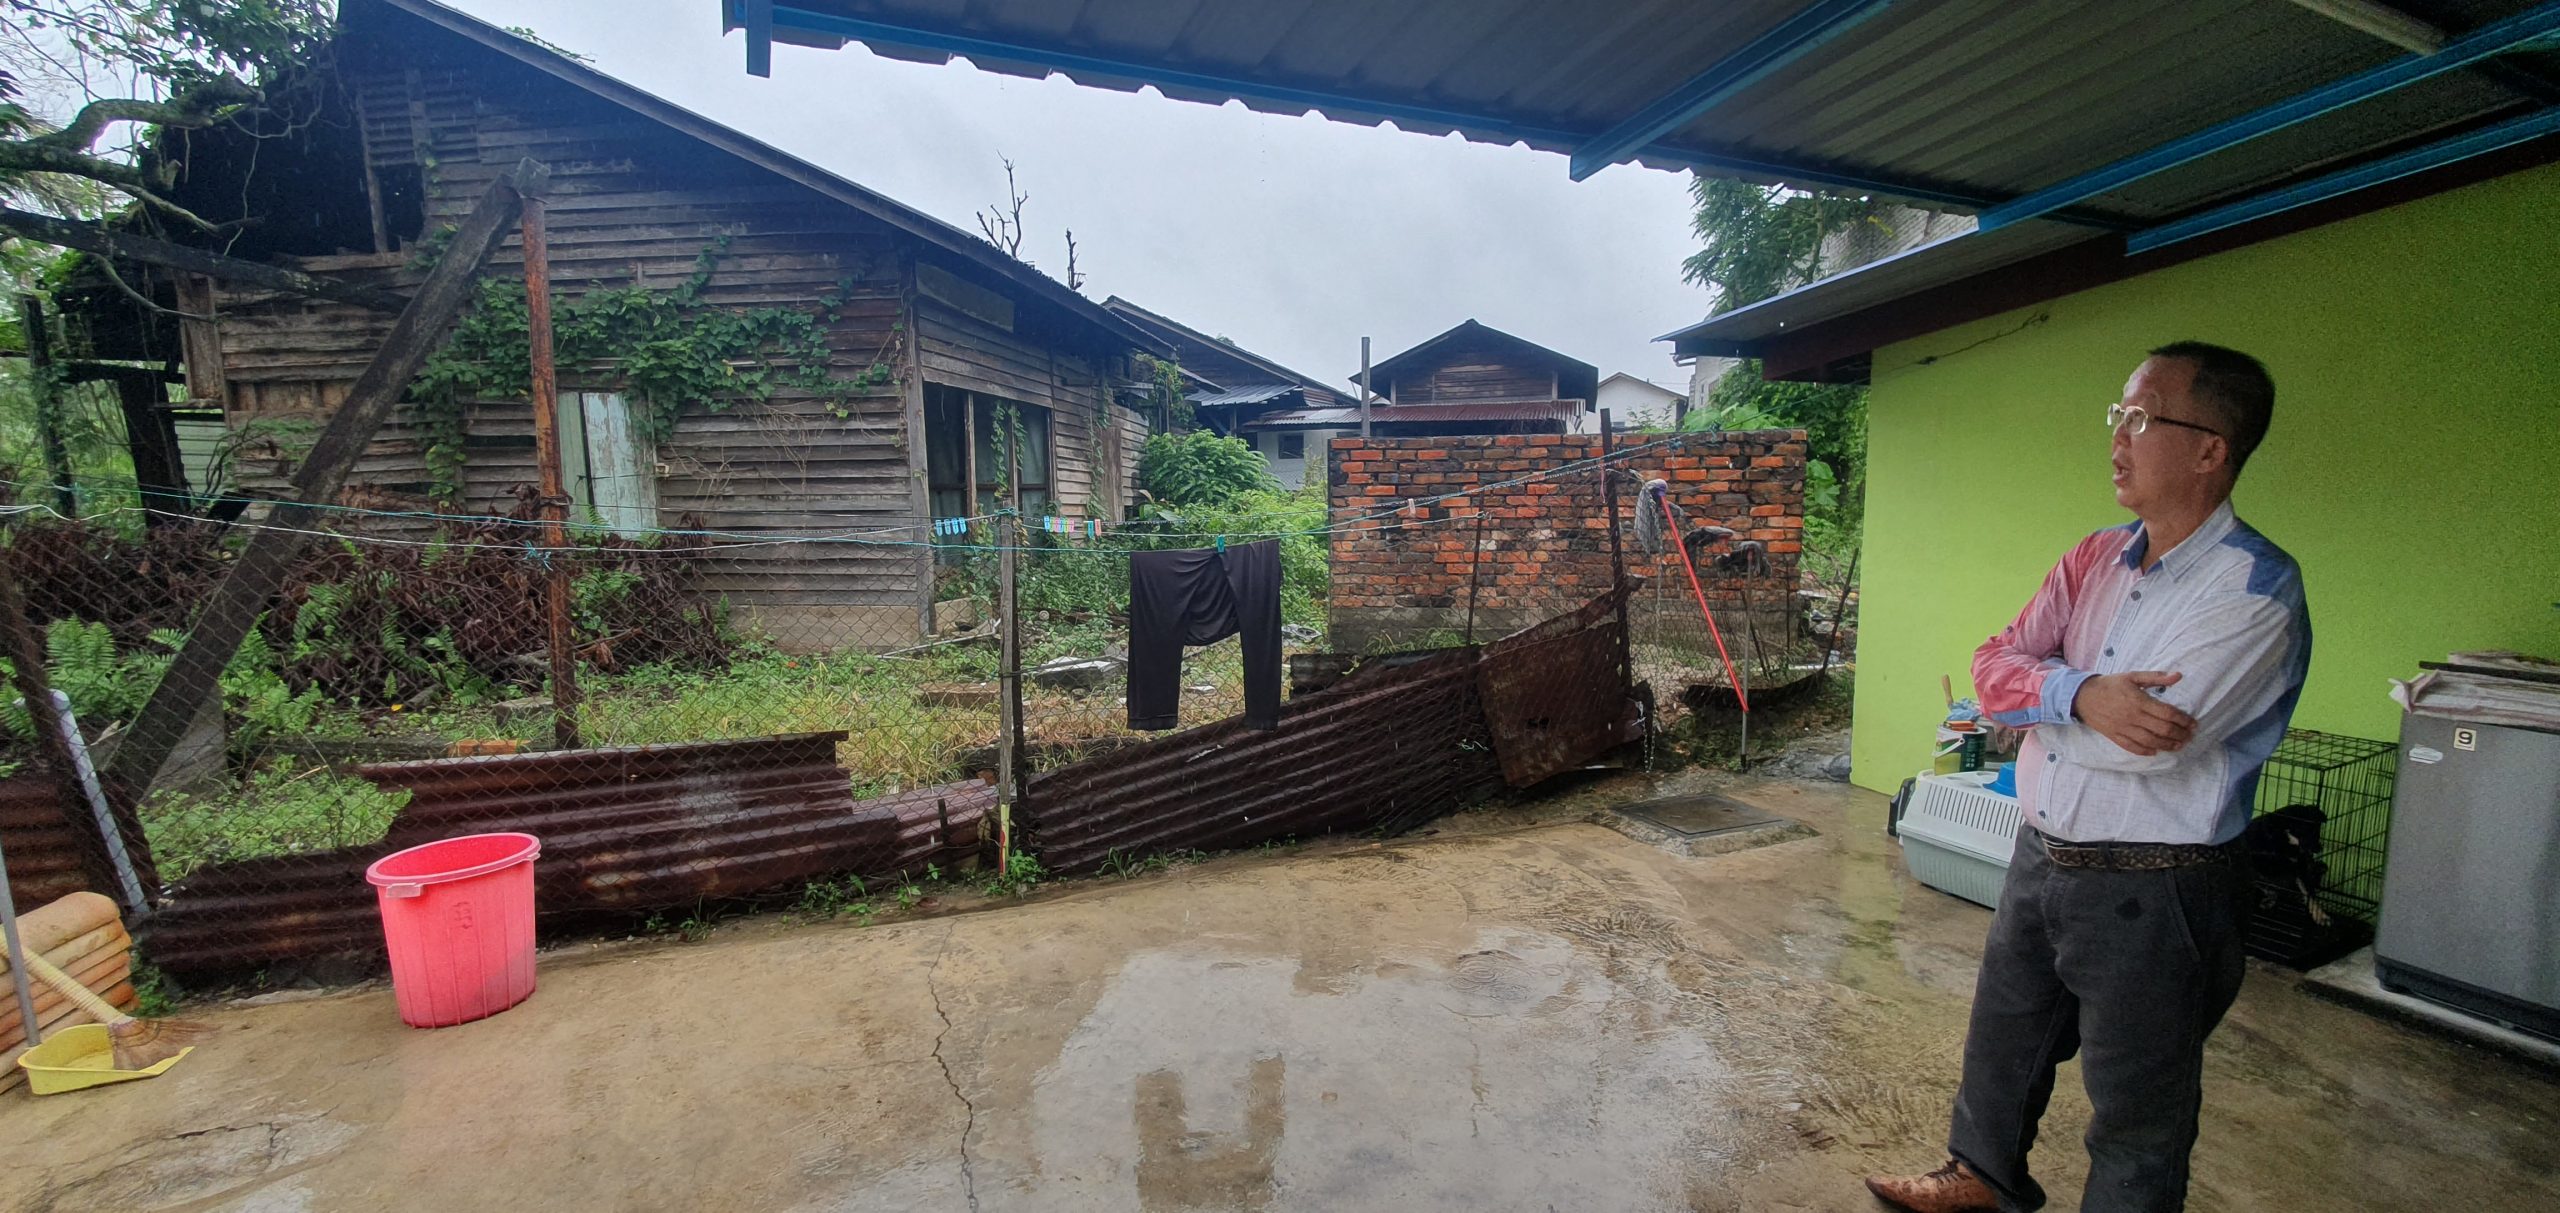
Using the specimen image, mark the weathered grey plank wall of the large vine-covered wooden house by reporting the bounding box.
[184,18,1144,647]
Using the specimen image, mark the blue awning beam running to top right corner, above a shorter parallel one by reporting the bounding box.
[1979,0,2560,230]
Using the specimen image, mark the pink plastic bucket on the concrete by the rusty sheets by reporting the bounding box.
[364,834,543,1029]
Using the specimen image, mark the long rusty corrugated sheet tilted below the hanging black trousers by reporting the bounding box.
[1024,650,1500,875]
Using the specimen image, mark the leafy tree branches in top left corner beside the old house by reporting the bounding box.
[0,0,330,228]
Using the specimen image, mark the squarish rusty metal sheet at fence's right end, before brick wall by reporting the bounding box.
[1477,586,1628,788]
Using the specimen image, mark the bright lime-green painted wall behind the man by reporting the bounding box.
[1853,166,2560,791]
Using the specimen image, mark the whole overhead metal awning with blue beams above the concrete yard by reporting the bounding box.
[722,0,2560,378]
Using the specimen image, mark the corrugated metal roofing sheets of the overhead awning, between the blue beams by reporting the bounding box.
[747,0,2532,220]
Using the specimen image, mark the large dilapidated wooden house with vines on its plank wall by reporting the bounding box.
[120,0,1170,647]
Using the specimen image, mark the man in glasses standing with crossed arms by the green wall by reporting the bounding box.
[1866,340,2312,1213]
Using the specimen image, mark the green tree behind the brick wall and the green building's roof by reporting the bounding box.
[1679,177,1892,545]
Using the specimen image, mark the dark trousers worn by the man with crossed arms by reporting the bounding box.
[1948,829,2250,1213]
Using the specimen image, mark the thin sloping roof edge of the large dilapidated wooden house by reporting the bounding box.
[366,0,1172,353]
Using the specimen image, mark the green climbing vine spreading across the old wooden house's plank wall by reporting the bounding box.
[410,235,904,504]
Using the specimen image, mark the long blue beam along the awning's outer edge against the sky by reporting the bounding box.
[727,0,2037,214]
